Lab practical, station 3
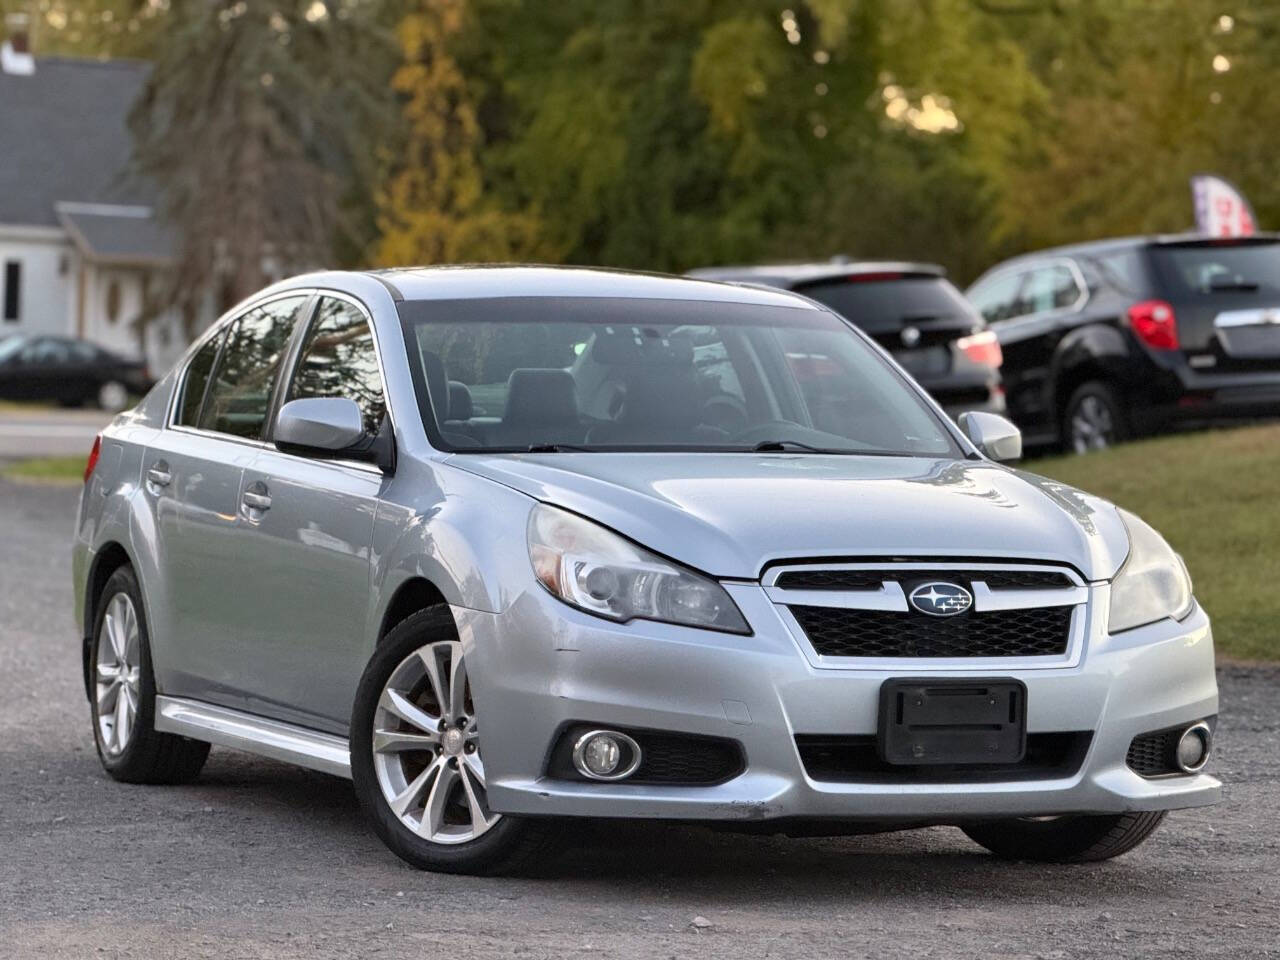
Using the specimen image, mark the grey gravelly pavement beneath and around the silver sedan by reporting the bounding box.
[0,479,1280,960]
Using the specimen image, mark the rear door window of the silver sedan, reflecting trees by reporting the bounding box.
[200,297,306,440]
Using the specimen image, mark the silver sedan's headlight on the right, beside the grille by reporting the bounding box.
[1107,509,1192,634]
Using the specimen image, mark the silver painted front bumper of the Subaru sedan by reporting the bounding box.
[453,584,1221,823]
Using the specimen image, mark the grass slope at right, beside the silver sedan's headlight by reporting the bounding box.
[1025,425,1280,660]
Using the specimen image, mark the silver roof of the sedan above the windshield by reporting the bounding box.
[358,265,819,310]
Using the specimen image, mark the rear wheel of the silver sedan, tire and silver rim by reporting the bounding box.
[88,566,209,783]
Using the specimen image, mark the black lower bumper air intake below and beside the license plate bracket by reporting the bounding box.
[796,732,1093,783]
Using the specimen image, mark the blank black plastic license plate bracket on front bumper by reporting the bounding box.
[877,677,1027,767]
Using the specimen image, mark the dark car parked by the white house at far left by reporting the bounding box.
[0,334,155,412]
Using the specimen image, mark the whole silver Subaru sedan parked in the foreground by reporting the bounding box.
[74,268,1220,872]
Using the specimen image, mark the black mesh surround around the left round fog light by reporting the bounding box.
[547,723,746,787]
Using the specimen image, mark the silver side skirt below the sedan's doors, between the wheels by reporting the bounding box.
[155,696,351,780]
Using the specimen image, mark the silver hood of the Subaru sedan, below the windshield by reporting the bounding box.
[448,453,1129,580]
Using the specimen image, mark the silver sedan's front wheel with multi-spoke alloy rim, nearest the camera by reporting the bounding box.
[351,607,553,876]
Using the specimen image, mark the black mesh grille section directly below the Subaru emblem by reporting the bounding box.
[787,605,1073,657]
